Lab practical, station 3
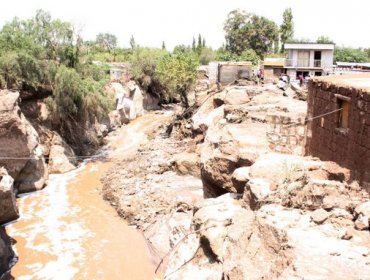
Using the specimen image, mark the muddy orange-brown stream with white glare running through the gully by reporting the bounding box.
[8,111,169,280]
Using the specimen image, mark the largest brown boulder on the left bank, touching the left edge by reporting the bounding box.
[0,91,48,192]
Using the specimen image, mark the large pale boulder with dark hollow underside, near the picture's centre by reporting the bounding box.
[201,122,268,197]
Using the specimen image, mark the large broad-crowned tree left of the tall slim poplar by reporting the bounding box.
[224,10,278,58]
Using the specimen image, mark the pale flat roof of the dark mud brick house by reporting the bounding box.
[312,74,370,93]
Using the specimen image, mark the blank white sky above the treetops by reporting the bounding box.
[0,0,370,49]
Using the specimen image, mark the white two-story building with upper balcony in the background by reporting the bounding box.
[284,43,334,79]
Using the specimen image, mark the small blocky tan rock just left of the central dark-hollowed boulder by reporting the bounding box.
[173,152,200,177]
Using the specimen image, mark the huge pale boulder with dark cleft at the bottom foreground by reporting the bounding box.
[165,194,290,279]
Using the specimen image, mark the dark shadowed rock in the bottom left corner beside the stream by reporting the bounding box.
[0,226,15,280]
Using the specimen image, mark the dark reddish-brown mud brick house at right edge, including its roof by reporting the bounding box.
[306,74,370,187]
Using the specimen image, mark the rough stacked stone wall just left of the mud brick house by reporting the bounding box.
[266,114,306,155]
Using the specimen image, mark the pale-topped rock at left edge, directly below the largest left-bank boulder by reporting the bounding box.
[0,168,19,225]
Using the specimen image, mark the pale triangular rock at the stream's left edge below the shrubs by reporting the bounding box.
[48,133,77,174]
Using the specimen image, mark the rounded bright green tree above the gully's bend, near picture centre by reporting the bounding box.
[156,53,198,107]
